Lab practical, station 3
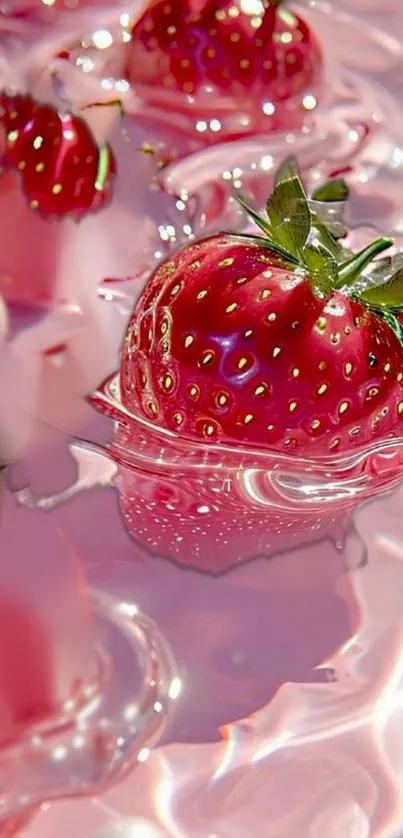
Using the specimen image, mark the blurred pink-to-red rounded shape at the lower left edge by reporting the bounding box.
[0,491,94,745]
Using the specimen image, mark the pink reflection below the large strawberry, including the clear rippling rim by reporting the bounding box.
[91,378,403,574]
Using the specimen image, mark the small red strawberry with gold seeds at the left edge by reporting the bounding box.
[0,93,115,218]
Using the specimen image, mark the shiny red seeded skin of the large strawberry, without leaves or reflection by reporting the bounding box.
[120,234,403,456]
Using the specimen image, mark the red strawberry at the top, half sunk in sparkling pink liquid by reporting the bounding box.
[128,0,322,142]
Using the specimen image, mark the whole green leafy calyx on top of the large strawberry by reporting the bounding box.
[236,158,403,312]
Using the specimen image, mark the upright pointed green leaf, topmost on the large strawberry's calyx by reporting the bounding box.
[266,158,311,257]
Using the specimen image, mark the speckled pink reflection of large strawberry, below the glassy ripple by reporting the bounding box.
[111,429,345,574]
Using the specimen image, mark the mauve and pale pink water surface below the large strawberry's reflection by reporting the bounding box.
[11,460,403,838]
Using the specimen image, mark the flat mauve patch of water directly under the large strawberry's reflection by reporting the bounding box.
[10,430,356,744]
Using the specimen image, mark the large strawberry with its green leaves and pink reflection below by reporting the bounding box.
[95,161,403,572]
